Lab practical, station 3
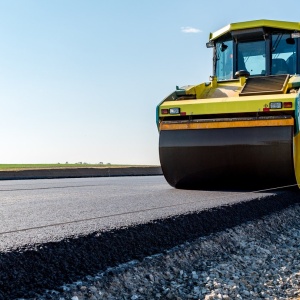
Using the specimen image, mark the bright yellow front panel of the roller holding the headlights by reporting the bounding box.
[159,94,296,117]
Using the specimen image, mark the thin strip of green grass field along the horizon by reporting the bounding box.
[0,163,133,171]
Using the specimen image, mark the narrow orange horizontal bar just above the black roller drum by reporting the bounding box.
[160,118,294,131]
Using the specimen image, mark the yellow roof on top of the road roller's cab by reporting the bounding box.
[209,19,300,41]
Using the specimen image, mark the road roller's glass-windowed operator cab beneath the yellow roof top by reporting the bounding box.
[207,20,300,81]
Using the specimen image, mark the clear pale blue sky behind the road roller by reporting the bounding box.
[0,0,300,165]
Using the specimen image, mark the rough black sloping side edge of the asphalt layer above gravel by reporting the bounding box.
[0,191,300,300]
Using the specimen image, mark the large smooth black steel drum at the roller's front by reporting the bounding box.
[159,119,296,189]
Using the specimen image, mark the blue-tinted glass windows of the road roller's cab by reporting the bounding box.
[215,33,296,80]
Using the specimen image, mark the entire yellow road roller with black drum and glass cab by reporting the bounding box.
[156,20,300,190]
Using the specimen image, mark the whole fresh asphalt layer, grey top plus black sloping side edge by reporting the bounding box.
[0,176,300,299]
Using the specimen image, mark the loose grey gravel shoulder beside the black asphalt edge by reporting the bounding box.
[35,204,300,300]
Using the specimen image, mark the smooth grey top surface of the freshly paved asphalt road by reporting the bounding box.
[0,176,286,251]
